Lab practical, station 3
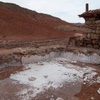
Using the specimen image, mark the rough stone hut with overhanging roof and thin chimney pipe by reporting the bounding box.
[79,4,100,49]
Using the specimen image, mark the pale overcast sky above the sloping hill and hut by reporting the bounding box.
[1,0,100,23]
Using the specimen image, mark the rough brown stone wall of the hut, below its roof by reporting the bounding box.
[77,18,100,49]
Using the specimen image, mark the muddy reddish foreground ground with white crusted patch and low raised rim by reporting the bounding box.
[0,45,100,100]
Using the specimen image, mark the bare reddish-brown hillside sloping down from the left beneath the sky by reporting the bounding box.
[0,2,78,40]
